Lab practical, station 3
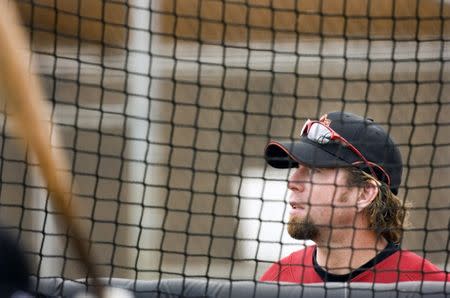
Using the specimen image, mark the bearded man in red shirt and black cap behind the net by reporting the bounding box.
[261,112,450,283]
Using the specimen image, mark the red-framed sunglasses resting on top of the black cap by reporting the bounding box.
[300,119,391,185]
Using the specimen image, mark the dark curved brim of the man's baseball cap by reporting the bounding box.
[265,138,354,169]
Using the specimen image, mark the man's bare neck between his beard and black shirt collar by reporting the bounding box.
[316,228,387,274]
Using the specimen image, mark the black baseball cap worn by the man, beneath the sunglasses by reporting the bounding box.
[265,112,403,194]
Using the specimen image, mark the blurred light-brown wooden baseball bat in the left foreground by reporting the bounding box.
[0,1,103,297]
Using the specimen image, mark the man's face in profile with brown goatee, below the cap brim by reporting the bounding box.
[288,165,357,241]
